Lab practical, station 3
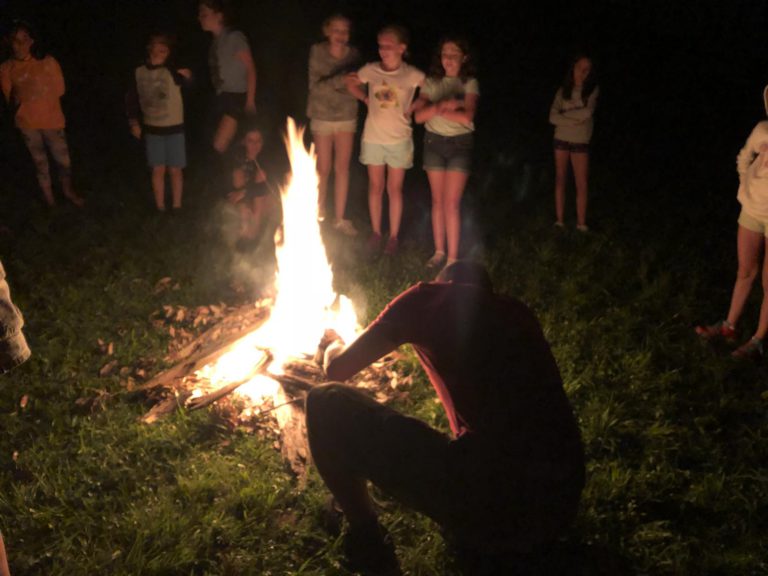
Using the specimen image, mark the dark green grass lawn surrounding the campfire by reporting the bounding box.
[0,127,768,576]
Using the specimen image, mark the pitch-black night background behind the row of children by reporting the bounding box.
[0,0,768,230]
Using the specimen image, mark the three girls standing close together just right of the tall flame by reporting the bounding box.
[307,15,479,266]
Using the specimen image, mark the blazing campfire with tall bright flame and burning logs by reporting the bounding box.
[130,118,410,473]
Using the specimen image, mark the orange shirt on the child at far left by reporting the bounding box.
[0,56,64,130]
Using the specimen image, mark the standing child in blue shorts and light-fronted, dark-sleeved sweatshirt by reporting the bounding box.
[126,34,191,212]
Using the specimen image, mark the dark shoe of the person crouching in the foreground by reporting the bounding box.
[342,524,402,576]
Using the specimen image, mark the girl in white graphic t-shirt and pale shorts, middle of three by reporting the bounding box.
[347,26,424,256]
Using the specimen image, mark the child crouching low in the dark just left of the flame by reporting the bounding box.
[227,128,271,240]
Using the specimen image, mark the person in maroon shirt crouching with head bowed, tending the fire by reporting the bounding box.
[306,261,584,575]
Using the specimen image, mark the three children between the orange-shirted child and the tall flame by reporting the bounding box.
[128,0,267,239]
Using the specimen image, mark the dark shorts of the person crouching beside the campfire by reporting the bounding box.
[307,384,584,552]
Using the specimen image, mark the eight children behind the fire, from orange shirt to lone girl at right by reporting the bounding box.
[0,7,599,267]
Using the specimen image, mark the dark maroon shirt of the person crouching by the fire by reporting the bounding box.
[369,282,580,459]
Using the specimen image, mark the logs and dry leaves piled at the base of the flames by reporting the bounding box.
[90,292,412,476]
